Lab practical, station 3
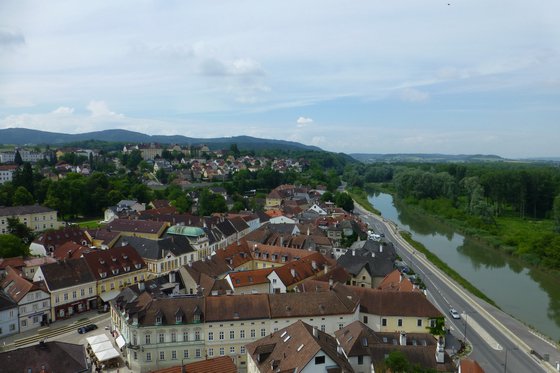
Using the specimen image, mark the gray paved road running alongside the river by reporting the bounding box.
[354,202,560,373]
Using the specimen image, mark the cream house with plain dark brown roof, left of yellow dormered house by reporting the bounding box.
[33,258,97,321]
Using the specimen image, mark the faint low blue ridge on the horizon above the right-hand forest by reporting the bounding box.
[350,153,508,163]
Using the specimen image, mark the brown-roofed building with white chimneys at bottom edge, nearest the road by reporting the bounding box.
[335,321,455,373]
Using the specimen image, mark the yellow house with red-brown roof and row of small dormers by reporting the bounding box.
[83,245,148,302]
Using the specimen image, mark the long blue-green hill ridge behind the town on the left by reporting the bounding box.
[0,128,322,150]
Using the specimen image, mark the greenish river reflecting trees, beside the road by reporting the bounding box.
[368,193,560,341]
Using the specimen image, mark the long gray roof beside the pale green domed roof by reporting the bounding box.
[115,235,194,260]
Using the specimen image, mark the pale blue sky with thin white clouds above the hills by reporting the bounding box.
[0,0,560,158]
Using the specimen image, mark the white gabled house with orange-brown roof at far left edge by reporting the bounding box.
[0,267,51,332]
